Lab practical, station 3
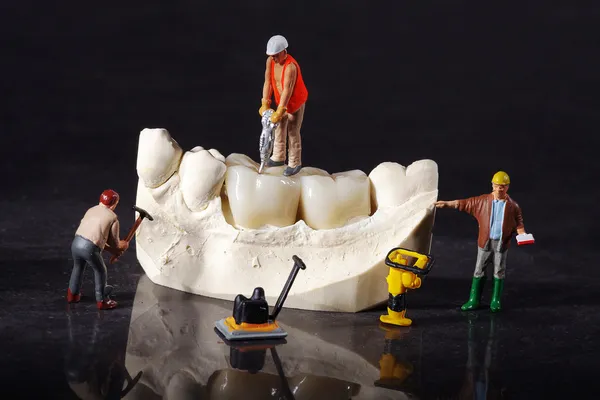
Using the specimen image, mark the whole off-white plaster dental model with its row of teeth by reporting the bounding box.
[136,129,438,312]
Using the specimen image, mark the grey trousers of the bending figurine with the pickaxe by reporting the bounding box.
[69,235,107,301]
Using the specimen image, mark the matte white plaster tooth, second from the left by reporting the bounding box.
[179,146,227,211]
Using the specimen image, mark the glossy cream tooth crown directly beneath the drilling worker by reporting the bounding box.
[225,154,300,229]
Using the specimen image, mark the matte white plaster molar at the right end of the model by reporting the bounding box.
[369,160,438,210]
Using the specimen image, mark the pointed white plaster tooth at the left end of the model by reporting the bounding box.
[137,128,183,188]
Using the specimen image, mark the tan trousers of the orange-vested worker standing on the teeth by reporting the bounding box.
[271,103,306,168]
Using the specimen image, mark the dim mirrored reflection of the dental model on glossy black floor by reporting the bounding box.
[125,276,410,400]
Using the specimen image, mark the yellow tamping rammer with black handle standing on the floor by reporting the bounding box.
[379,248,433,326]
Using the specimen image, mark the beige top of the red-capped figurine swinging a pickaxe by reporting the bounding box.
[75,204,119,250]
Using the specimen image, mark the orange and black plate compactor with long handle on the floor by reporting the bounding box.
[215,256,306,340]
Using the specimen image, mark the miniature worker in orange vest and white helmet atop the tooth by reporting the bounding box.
[258,35,308,176]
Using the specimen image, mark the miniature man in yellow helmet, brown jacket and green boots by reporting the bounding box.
[435,171,525,312]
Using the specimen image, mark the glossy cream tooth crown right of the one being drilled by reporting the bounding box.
[300,170,371,229]
